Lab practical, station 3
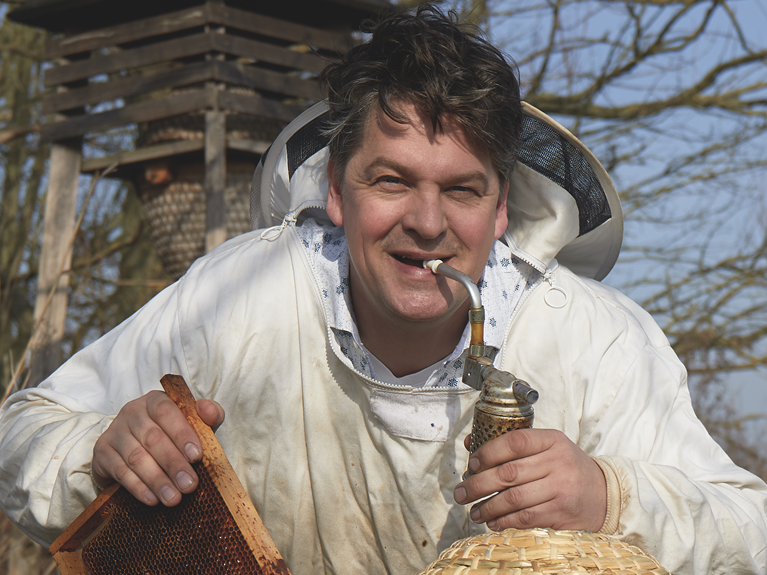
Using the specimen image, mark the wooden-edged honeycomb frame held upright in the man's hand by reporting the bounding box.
[50,375,290,575]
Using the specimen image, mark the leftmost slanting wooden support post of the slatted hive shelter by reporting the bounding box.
[30,138,82,386]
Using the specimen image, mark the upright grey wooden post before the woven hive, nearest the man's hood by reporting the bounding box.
[205,110,226,253]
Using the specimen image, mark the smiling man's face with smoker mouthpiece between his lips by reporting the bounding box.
[327,104,507,329]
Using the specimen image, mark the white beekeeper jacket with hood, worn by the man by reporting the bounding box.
[0,101,767,575]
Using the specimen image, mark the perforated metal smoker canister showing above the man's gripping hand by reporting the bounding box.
[464,365,538,479]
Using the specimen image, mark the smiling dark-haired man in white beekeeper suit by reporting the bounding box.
[0,7,767,575]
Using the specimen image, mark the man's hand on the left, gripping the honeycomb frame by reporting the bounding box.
[92,391,224,507]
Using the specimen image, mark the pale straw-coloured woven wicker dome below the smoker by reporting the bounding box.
[418,529,670,575]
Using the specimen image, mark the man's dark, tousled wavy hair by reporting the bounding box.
[320,4,522,186]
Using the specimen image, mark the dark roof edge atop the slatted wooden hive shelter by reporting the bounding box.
[8,0,392,34]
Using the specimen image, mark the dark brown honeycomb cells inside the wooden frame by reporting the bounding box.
[79,464,263,575]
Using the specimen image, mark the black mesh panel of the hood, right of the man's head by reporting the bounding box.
[519,116,611,236]
